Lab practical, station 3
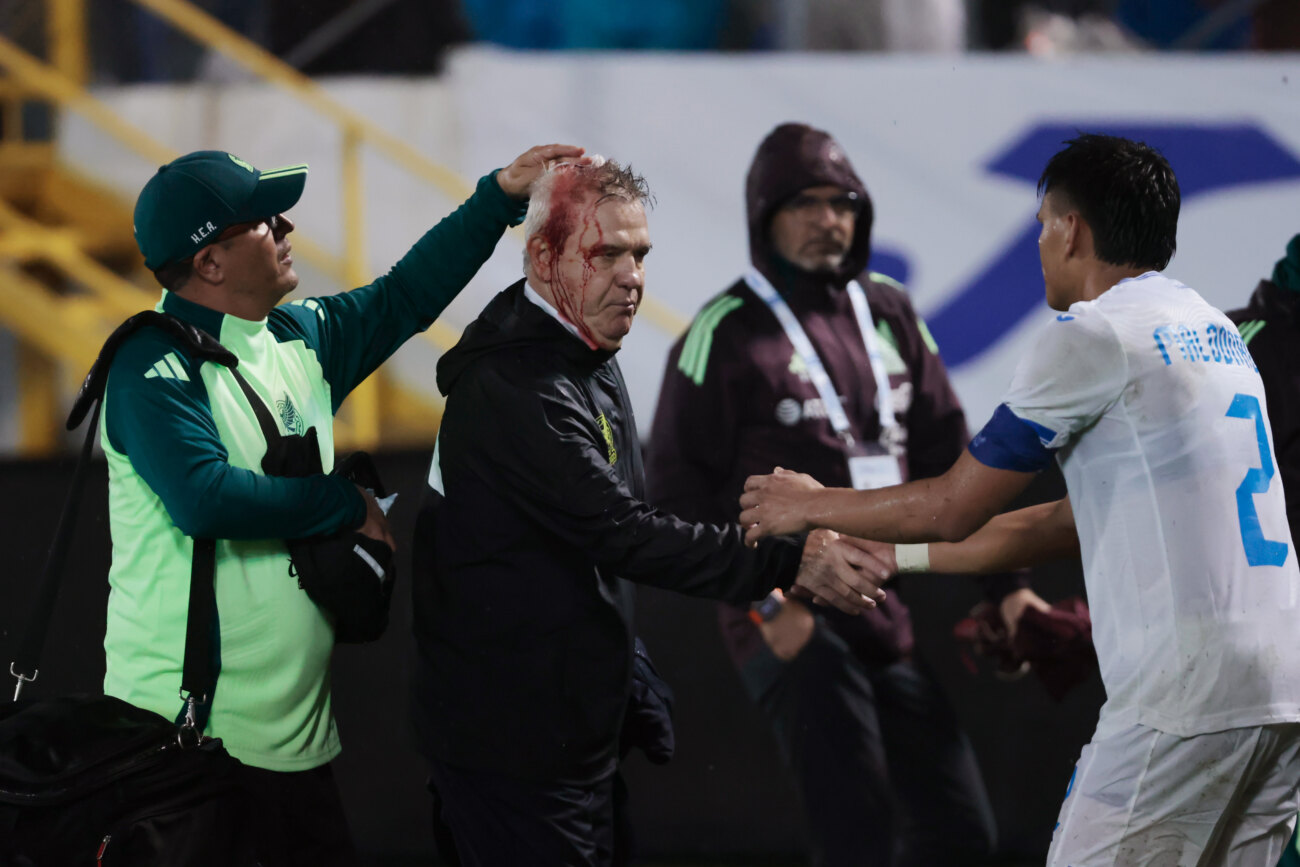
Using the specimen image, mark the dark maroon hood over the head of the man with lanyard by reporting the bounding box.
[745,123,875,286]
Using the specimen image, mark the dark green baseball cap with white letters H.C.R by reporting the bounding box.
[134,151,307,270]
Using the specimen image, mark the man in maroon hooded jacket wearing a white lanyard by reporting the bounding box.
[647,123,1045,867]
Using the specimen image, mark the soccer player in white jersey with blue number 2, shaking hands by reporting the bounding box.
[741,135,1300,867]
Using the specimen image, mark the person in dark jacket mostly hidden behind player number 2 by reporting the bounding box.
[1227,235,1300,867]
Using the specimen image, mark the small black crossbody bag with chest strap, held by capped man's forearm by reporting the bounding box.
[231,369,397,643]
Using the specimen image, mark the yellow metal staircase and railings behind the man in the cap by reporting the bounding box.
[0,0,452,456]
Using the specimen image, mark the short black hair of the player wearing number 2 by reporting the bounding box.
[1039,134,1180,270]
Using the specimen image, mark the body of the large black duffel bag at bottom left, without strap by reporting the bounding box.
[0,695,255,867]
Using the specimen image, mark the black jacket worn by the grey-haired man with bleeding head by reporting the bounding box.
[412,281,802,785]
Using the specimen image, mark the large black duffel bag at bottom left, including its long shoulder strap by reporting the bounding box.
[0,312,256,867]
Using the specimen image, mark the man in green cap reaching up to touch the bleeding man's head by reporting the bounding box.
[101,144,582,867]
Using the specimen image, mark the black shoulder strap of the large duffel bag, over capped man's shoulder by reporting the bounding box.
[9,311,236,717]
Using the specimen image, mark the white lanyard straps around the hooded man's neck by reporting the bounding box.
[745,269,898,446]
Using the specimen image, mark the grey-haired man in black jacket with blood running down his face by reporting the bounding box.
[413,157,884,866]
